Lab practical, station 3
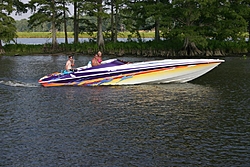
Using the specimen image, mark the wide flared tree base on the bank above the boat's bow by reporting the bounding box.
[178,38,202,56]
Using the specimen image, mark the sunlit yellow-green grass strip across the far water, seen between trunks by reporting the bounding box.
[17,32,154,38]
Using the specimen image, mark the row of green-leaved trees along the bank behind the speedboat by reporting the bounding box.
[0,0,250,56]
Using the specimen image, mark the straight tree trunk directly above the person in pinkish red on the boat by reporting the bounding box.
[97,0,104,52]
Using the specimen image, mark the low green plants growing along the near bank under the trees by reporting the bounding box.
[1,38,247,56]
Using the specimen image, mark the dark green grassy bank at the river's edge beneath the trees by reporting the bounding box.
[3,39,250,58]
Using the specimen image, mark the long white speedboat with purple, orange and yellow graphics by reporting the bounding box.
[38,59,224,87]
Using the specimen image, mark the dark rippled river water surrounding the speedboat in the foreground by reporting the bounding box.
[0,55,250,167]
